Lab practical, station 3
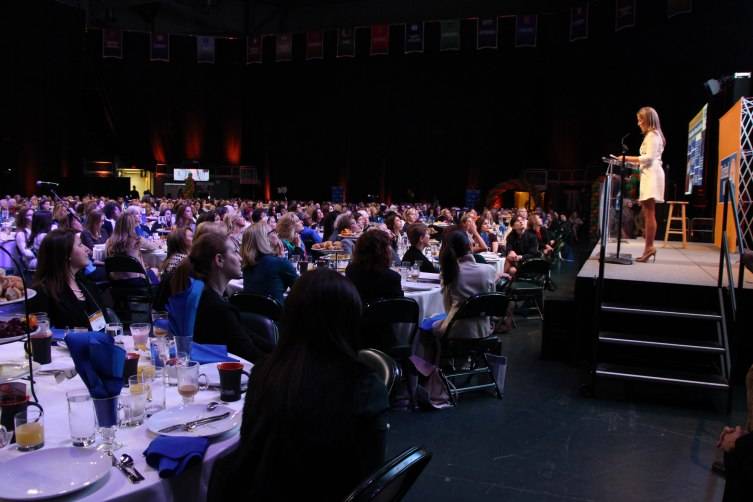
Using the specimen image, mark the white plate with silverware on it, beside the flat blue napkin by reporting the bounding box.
[146,404,241,438]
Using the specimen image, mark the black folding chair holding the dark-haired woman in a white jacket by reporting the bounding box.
[440,292,510,402]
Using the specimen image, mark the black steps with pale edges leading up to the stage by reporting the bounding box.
[592,289,731,404]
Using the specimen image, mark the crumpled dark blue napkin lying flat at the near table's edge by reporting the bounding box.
[144,436,209,478]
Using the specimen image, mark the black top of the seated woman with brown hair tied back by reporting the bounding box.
[193,286,273,363]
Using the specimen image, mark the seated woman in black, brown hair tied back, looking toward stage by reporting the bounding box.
[171,232,272,363]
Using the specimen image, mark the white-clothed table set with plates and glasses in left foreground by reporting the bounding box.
[0,318,252,501]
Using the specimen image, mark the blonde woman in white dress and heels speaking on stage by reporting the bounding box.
[625,106,666,262]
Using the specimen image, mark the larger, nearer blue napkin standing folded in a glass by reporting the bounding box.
[65,331,126,427]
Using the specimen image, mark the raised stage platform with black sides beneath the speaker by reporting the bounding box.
[570,239,753,382]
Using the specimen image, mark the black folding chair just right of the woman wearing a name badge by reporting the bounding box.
[105,256,154,324]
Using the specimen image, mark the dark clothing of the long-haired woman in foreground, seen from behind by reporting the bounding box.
[207,358,389,502]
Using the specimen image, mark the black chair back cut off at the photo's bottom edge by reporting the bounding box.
[345,446,431,502]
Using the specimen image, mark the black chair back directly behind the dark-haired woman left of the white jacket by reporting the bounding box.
[362,298,420,359]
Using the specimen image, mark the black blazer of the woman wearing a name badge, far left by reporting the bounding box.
[29,274,113,328]
